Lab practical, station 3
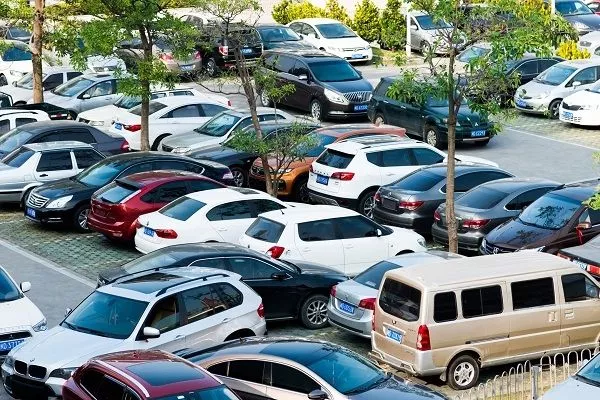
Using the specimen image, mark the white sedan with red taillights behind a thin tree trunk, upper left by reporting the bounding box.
[110,96,229,150]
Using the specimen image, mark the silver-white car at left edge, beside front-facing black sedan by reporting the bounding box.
[0,141,104,204]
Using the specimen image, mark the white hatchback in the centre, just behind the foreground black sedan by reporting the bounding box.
[240,206,426,276]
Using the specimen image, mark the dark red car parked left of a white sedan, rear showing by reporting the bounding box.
[87,171,225,241]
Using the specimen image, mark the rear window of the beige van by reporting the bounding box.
[379,278,421,322]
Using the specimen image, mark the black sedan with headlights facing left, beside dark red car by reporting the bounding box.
[24,152,233,232]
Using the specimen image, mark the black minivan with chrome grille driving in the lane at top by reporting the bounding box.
[257,50,373,120]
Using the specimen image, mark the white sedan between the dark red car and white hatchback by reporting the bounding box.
[135,188,294,253]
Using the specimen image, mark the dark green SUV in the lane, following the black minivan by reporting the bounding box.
[367,78,493,149]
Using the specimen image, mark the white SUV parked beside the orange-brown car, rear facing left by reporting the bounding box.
[308,135,498,217]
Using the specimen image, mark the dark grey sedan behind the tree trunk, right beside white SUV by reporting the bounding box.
[373,163,513,235]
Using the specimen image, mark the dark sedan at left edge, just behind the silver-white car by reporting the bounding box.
[0,121,129,158]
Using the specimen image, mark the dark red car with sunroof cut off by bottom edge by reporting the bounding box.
[62,350,240,400]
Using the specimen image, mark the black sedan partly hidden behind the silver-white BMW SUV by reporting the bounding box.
[98,243,347,329]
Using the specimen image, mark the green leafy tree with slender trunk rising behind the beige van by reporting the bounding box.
[388,0,554,252]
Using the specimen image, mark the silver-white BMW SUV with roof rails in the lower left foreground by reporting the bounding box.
[2,267,266,397]
